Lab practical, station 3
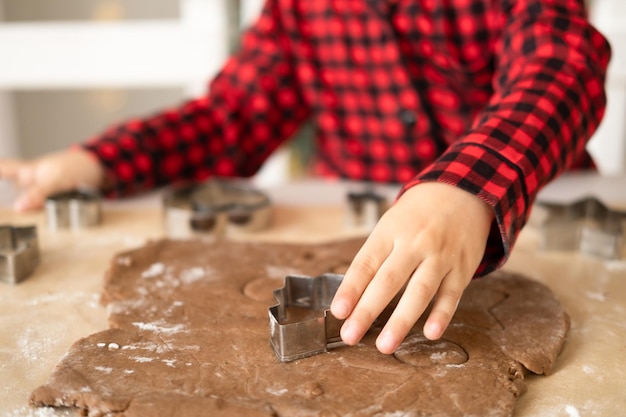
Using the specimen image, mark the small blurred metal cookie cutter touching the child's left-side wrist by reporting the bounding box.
[46,190,102,230]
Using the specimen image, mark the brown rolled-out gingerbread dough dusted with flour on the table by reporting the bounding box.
[30,239,569,417]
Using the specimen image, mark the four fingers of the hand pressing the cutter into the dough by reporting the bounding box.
[331,242,473,354]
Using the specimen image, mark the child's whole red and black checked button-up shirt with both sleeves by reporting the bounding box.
[85,0,610,273]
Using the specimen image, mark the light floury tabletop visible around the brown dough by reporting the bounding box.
[0,176,626,417]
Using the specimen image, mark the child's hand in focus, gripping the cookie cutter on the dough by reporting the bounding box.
[331,183,494,353]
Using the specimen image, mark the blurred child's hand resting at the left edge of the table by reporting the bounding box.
[0,150,104,211]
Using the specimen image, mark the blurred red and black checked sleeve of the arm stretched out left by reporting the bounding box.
[83,1,309,197]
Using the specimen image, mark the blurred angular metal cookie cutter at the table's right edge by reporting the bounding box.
[538,197,626,259]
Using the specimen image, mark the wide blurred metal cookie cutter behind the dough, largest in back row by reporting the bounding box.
[163,179,271,237]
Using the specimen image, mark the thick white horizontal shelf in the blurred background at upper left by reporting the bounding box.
[0,20,227,90]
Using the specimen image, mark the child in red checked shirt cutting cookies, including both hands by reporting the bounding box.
[0,0,610,353]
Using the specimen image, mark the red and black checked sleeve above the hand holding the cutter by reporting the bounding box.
[405,0,610,275]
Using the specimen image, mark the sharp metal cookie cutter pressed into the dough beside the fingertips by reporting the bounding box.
[269,273,343,362]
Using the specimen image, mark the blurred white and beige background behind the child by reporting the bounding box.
[0,0,626,184]
